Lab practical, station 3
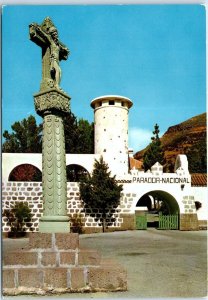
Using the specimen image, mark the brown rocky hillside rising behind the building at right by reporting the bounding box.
[134,113,206,173]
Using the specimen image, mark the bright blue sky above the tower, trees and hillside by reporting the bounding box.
[2,5,206,151]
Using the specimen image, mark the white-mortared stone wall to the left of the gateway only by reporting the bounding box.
[2,182,136,232]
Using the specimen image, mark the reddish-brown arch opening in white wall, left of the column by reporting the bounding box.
[8,164,42,182]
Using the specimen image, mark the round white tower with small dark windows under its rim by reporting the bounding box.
[91,95,133,177]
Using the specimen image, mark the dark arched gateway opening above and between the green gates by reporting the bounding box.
[135,190,180,228]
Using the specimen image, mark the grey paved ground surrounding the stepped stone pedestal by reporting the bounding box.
[3,228,207,300]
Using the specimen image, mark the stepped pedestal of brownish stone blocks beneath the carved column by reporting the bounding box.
[3,233,127,295]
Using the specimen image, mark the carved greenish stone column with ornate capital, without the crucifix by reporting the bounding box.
[34,88,70,232]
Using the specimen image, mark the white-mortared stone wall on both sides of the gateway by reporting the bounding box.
[2,182,206,234]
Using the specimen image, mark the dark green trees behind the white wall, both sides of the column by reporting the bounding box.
[2,112,94,154]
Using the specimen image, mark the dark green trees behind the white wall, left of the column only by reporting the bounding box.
[2,116,42,153]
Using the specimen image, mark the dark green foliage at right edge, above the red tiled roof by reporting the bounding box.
[186,139,207,173]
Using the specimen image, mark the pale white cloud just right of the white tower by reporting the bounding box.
[129,127,153,153]
